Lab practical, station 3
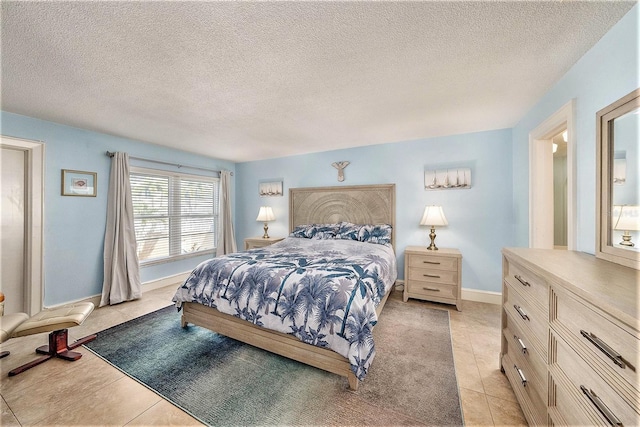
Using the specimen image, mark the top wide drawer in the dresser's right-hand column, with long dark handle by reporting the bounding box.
[551,291,640,391]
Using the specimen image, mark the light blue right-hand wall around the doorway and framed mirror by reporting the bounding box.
[513,5,640,254]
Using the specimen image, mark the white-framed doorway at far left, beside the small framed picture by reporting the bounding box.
[0,136,44,316]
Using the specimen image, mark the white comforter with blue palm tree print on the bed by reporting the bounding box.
[173,237,397,380]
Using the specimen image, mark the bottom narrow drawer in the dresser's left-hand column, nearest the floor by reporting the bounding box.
[502,353,547,425]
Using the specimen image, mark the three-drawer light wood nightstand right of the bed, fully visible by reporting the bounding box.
[402,246,462,311]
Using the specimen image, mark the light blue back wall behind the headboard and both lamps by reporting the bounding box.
[236,129,514,291]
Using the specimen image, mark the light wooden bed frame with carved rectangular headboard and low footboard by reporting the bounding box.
[182,184,396,390]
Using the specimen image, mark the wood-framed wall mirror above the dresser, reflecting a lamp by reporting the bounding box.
[596,89,640,269]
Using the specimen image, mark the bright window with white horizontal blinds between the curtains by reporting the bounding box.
[130,168,219,264]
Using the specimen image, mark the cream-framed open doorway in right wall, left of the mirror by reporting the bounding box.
[529,100,576,250]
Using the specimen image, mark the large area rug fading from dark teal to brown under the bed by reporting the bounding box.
[86,298,463,426]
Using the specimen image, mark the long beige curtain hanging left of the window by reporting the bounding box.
[100,153,142,307]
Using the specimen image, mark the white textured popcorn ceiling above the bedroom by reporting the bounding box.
[1,0,635,162]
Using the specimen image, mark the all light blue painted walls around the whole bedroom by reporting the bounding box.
[0,5,640,305]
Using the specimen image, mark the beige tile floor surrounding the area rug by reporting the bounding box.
[0,286,526,426]
